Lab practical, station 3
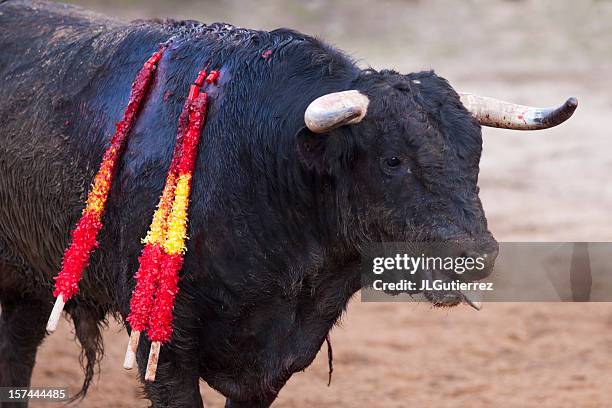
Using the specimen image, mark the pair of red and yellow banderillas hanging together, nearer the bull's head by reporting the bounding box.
[124,71,218,381]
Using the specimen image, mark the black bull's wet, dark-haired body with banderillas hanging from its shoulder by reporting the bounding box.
[0,1,502,407]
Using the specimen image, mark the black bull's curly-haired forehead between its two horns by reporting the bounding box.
[361,71,482,182]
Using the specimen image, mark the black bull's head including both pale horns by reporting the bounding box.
[299,71,577,306]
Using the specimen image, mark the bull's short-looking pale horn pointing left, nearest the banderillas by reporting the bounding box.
[304,90,370,133]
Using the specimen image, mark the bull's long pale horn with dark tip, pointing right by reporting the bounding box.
[459,93,578,130]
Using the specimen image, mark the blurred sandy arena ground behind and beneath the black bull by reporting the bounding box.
[23,0,612,408]
